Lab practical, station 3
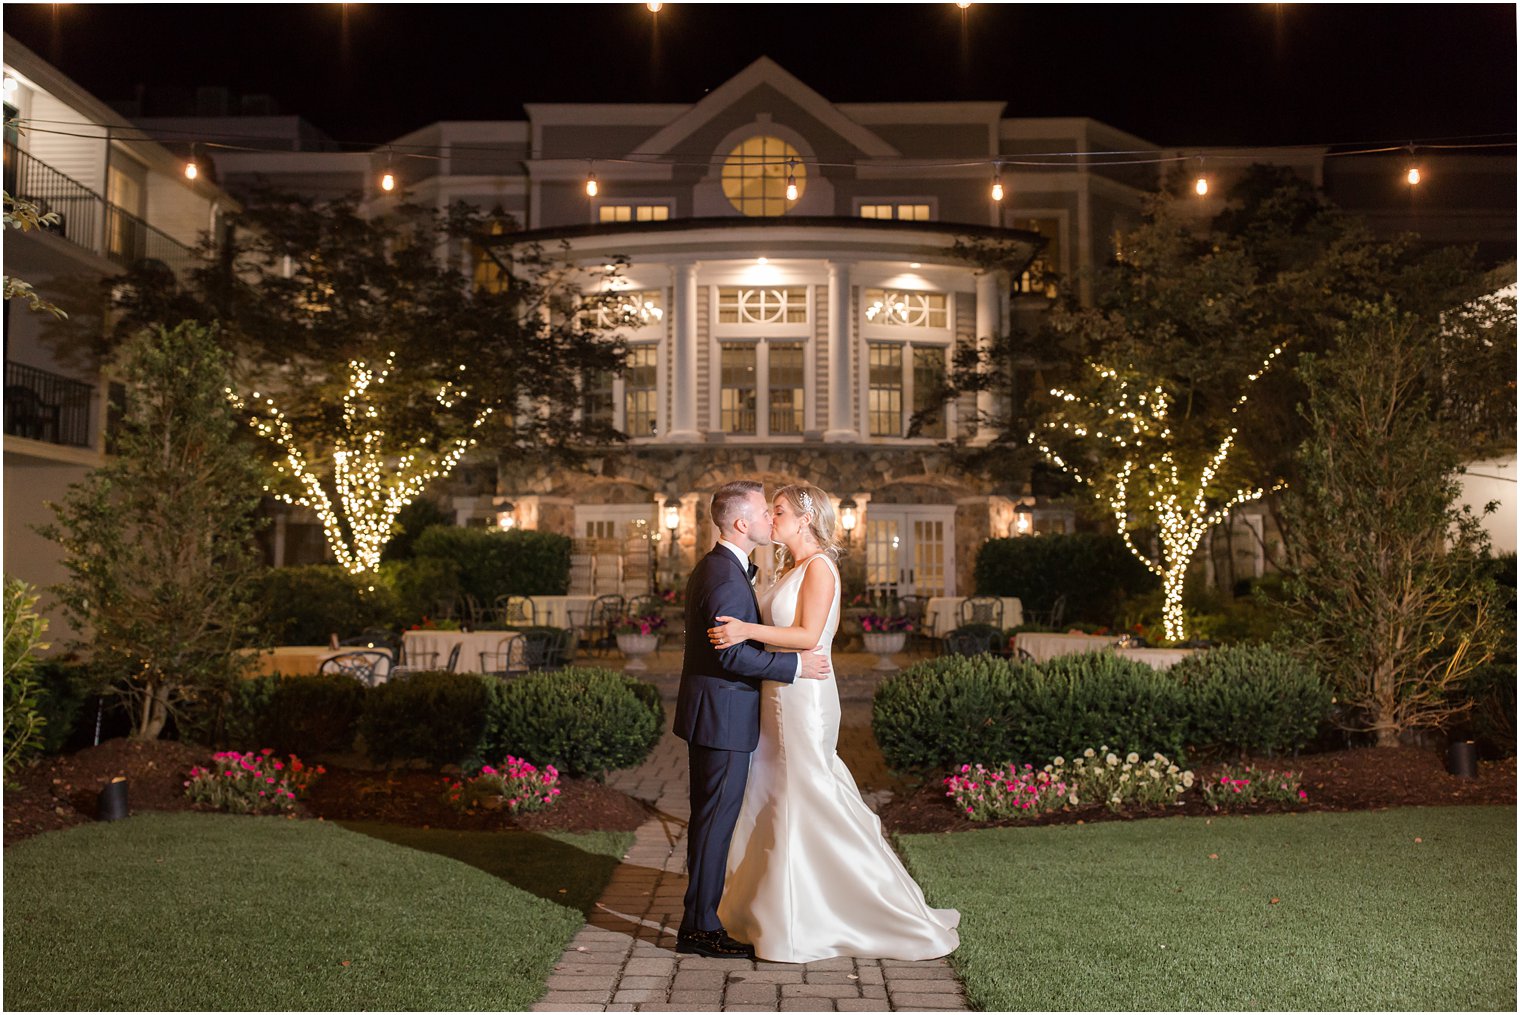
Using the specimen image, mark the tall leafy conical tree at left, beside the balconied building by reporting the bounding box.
[41,322,260,740]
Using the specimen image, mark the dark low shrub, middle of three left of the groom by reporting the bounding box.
[359,670,489,764]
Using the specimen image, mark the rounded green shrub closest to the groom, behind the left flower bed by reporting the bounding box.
[485,667,664,778]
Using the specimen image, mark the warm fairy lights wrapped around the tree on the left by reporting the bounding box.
[226,353,491,574]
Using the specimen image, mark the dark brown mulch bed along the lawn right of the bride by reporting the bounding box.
[880,748,1515,834]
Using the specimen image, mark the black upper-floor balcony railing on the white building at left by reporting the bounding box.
[5,144,205,275]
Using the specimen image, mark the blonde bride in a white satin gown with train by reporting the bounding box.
[708,486,961,962]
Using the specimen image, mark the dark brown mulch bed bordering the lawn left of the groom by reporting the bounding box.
[5,738,651,846]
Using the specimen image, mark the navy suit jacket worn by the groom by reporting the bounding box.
[675,545,798,751]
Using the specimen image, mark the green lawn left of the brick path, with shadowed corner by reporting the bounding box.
[5,813,632,1010]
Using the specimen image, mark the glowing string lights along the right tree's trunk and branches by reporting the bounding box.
[1029,345,1284,641]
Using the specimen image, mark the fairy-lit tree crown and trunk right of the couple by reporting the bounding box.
[1029,346,1283,641]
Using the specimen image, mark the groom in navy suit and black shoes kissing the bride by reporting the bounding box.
[675,480,828,959]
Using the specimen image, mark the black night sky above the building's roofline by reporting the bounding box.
[5,3,1515,146]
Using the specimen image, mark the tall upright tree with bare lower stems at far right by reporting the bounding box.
[1284,304,1499,746]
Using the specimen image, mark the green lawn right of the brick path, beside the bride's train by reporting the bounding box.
[898,807,1515,1012]
